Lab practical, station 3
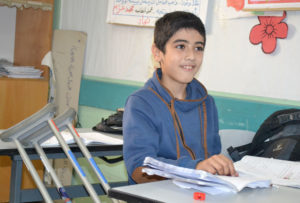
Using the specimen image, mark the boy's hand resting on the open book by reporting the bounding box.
[196,154,238,176]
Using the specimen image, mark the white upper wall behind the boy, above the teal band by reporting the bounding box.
[60,0,300,101]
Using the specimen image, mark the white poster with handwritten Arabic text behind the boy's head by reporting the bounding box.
[107,0,208,27]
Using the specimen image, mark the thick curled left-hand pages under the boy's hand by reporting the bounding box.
[142,157,271,194]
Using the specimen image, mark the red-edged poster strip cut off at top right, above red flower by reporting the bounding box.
[243,0,300,11]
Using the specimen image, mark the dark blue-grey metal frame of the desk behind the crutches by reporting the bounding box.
[0,130,127,203]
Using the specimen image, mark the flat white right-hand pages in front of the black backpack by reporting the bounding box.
[234,156,300,188]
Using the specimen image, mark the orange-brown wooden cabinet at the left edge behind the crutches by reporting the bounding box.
[0,0,54,202]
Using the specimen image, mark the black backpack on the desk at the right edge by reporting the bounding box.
[227,109,300,161]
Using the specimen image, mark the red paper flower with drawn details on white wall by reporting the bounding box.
[250,11,288,54]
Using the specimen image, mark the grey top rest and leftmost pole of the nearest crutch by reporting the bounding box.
[1,104,55,203]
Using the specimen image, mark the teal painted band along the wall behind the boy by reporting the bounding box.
[79,78,300,131]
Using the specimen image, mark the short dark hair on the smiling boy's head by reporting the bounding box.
[154,11,206,53]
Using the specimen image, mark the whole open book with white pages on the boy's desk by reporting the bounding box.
[143,156,300,194]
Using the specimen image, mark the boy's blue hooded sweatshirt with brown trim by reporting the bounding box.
[123,69,221,184]
